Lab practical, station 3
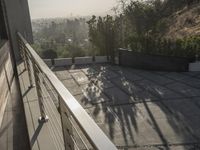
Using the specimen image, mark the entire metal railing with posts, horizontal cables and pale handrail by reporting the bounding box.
[17,33,117,150]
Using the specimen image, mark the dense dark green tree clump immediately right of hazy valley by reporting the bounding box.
[87,15,117,59]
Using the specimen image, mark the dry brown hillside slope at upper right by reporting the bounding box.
[162,4,200,39]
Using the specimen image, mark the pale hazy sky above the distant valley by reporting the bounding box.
[28,0,116,19]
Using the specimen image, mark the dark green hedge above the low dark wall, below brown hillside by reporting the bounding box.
[131,36,200,58]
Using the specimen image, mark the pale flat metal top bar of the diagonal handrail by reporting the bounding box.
[17,32,117,150]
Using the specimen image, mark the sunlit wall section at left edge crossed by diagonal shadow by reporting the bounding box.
[0,42,14,126]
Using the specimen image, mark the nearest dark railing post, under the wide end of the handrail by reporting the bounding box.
[58,97,75,150]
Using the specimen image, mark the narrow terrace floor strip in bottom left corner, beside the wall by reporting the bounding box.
[0,78,30,150]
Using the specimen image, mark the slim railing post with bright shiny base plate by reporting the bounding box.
[32,62,49,122]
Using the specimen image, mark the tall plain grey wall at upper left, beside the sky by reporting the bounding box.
[2,0,33,60]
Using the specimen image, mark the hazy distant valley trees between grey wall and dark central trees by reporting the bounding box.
[32,18,90,57]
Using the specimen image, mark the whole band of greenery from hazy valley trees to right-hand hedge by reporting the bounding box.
[33,0,200,59]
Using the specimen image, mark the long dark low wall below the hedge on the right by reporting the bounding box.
[119,49,189,71]
